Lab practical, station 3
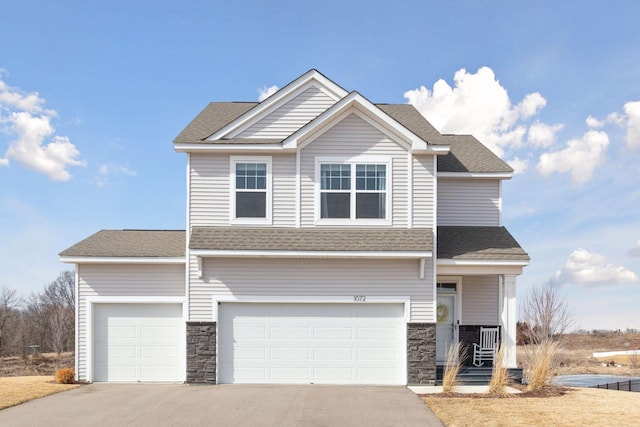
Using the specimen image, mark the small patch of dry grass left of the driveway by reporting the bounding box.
[0,376,80,409]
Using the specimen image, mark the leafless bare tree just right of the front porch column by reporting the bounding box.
[520,282,573,344]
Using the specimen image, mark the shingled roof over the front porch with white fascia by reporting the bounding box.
[438,226,529,261]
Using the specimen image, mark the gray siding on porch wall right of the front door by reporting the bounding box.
[461,276,500,325]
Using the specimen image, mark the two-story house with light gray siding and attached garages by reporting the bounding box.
[60,70,529,385]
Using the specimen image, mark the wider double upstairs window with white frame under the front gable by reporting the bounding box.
[319,162,388,220]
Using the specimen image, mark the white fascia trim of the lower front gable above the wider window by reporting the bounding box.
[282,91,427,150]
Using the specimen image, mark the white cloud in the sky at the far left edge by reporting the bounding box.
[0,75,85,181]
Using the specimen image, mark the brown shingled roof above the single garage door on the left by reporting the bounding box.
[60,230,186,258]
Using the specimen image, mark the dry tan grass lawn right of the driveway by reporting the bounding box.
[422,388,640,427]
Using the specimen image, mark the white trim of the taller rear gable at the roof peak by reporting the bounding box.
[207,69,347,141]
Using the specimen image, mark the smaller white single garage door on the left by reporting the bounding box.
[93,304,185,382]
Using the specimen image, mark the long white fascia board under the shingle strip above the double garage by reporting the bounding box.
[190,249,433,259]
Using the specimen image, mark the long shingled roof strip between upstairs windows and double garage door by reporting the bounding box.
[189,227,433,252]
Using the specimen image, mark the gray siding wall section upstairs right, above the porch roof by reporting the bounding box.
[438,178,501,226]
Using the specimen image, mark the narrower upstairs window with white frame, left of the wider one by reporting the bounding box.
[231,157,271,223]
